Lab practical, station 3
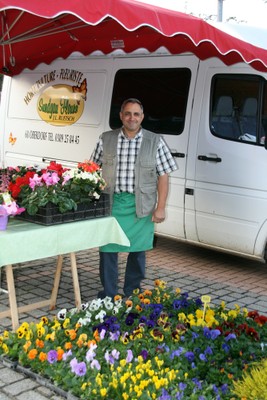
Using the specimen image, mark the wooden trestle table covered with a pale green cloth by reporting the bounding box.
[0,217,129,330]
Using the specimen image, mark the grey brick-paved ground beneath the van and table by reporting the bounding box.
[0,238,267,400]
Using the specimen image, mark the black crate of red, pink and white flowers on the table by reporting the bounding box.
[3,160,107,225]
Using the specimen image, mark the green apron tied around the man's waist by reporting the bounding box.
[100,192,154,253]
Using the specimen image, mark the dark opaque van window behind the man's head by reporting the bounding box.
[109,68,191,135]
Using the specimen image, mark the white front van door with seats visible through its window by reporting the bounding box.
[195,62,267,255]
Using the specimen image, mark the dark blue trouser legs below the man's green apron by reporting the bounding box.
[99,251,146,298]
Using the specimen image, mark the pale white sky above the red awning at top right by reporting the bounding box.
[136,0,267,28]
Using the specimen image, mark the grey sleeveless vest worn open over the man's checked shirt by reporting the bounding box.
[102,129,160,218]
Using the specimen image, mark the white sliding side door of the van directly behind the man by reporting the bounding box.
[110,55,199,238]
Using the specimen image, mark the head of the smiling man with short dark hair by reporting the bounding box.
[120,98,144,138]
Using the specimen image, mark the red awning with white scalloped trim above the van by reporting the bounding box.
[0,0,267,76]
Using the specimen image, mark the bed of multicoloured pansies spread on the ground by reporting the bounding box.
[0,280,267,400]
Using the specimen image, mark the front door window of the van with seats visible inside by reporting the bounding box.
[210,74,267,145]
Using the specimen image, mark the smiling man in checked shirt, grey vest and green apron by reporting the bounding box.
[91,98,177,298]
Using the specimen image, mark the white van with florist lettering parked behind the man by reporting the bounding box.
[0,51,267,261]
